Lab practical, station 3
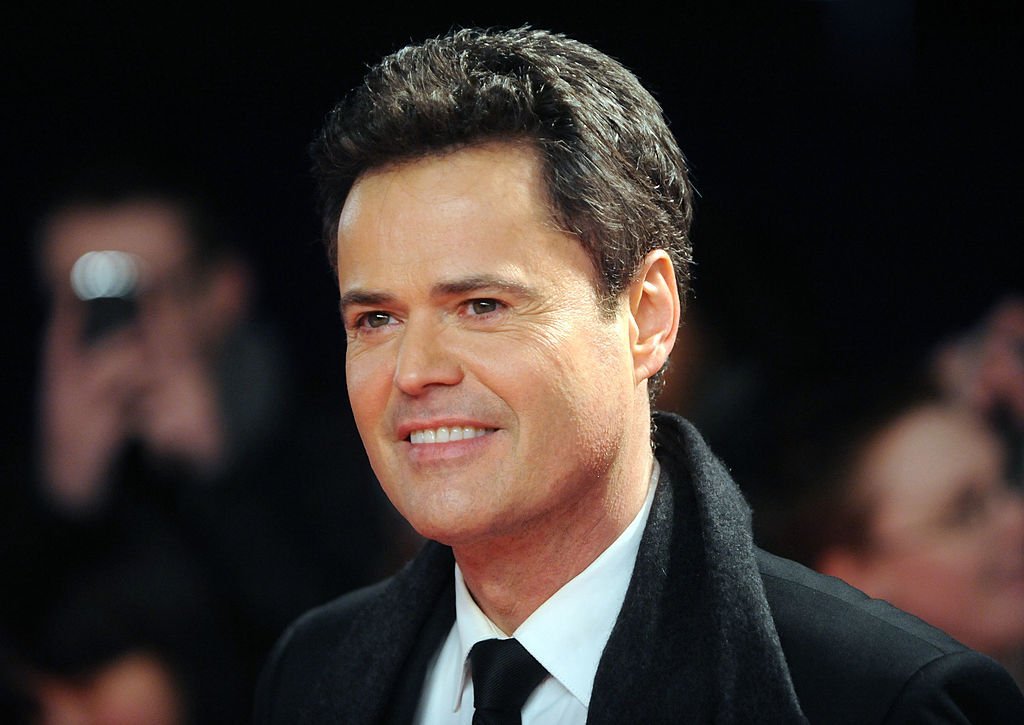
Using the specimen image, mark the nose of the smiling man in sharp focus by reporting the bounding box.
[394,319,463,395]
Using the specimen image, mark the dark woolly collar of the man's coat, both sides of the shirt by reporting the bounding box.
[308,414,804,725]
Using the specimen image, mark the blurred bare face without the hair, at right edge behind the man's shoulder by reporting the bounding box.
[842,404,1024,656]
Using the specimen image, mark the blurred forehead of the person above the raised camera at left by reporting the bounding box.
[43,201,190,284]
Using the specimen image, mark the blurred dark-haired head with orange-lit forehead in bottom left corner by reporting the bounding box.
[16,531,241,725]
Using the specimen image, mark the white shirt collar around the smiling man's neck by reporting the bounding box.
[453,459,660,711]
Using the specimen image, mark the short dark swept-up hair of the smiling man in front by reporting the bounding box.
[311,28,693,391]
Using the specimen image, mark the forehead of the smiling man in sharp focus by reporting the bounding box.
[338,143,596,291]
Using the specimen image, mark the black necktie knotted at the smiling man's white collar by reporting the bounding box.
[469,639,548,725]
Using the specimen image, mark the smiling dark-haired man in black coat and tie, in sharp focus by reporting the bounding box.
[256,29,1024,723]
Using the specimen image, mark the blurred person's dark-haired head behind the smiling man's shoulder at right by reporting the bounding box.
[772,397,1024,681]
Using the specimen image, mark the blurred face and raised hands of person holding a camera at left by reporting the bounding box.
[39,172,256,515]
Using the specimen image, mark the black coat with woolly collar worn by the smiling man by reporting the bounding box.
[256,416,1024,724]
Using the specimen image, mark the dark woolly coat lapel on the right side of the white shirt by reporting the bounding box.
[588,416,804,724]
